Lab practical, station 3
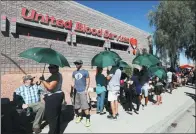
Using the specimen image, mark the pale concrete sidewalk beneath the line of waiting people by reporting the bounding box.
[42,87,195,133]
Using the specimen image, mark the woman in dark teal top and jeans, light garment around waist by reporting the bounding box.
[95,67,106,115]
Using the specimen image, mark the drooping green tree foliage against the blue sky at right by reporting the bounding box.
[148,1,196,67]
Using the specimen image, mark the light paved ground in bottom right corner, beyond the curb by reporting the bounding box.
[163,104,195,133]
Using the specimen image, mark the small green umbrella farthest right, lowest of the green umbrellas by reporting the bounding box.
[149,66,167,79]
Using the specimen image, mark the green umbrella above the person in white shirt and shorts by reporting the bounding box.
[91,51,121,68]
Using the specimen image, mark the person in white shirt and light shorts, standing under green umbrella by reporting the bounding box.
[107,66,123,120]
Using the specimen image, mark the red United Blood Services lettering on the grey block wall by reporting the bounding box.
[21,7,136,44]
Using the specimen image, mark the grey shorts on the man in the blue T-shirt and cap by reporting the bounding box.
[74,92,90,110]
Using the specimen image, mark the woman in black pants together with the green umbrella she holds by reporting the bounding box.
[19,45,70,134]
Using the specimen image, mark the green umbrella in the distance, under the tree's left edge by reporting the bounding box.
[132,54,160,68]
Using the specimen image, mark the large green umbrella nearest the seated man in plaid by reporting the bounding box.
[19,47,70,67]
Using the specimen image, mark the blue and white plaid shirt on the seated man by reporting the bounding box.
[16,84,44,104]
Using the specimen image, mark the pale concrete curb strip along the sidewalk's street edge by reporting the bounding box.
[144,99,195,133]
